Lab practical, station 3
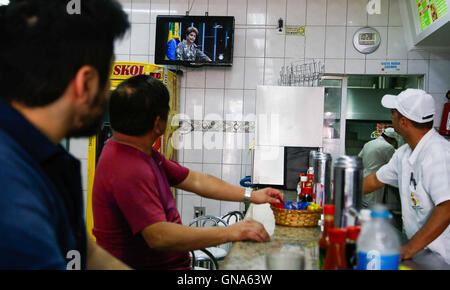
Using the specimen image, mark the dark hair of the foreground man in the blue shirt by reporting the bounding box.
[0,0,130,107]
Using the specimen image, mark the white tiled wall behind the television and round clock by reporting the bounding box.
[70,0,450,224]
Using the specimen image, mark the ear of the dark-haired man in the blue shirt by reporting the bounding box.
[73,65,99,103]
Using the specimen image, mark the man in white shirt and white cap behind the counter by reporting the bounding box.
[363,89,450,264]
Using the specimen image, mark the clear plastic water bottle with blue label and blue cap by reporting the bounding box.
[356,205,400,270]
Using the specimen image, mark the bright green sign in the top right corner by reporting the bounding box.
[416,0,448,31]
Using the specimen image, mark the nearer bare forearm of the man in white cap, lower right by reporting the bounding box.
[403,201,450,258]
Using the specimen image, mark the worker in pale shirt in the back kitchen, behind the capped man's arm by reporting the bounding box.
[358,128,397,207]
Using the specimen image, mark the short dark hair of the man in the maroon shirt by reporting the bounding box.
[109,75,170,136]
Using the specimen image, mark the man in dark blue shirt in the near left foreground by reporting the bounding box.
[0,0,129,269]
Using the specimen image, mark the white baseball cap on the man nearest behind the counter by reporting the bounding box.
[381,89,435,123]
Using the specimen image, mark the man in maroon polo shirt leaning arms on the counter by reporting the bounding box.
[92,75,283,269]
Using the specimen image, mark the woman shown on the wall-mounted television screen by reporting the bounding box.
[176,26,211,62]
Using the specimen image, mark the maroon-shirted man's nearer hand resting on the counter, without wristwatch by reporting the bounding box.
[227,219,270,242]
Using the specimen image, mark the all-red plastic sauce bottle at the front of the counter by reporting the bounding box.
[323,228,347,270]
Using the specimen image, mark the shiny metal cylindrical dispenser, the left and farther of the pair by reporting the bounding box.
[310,151,333,208]
